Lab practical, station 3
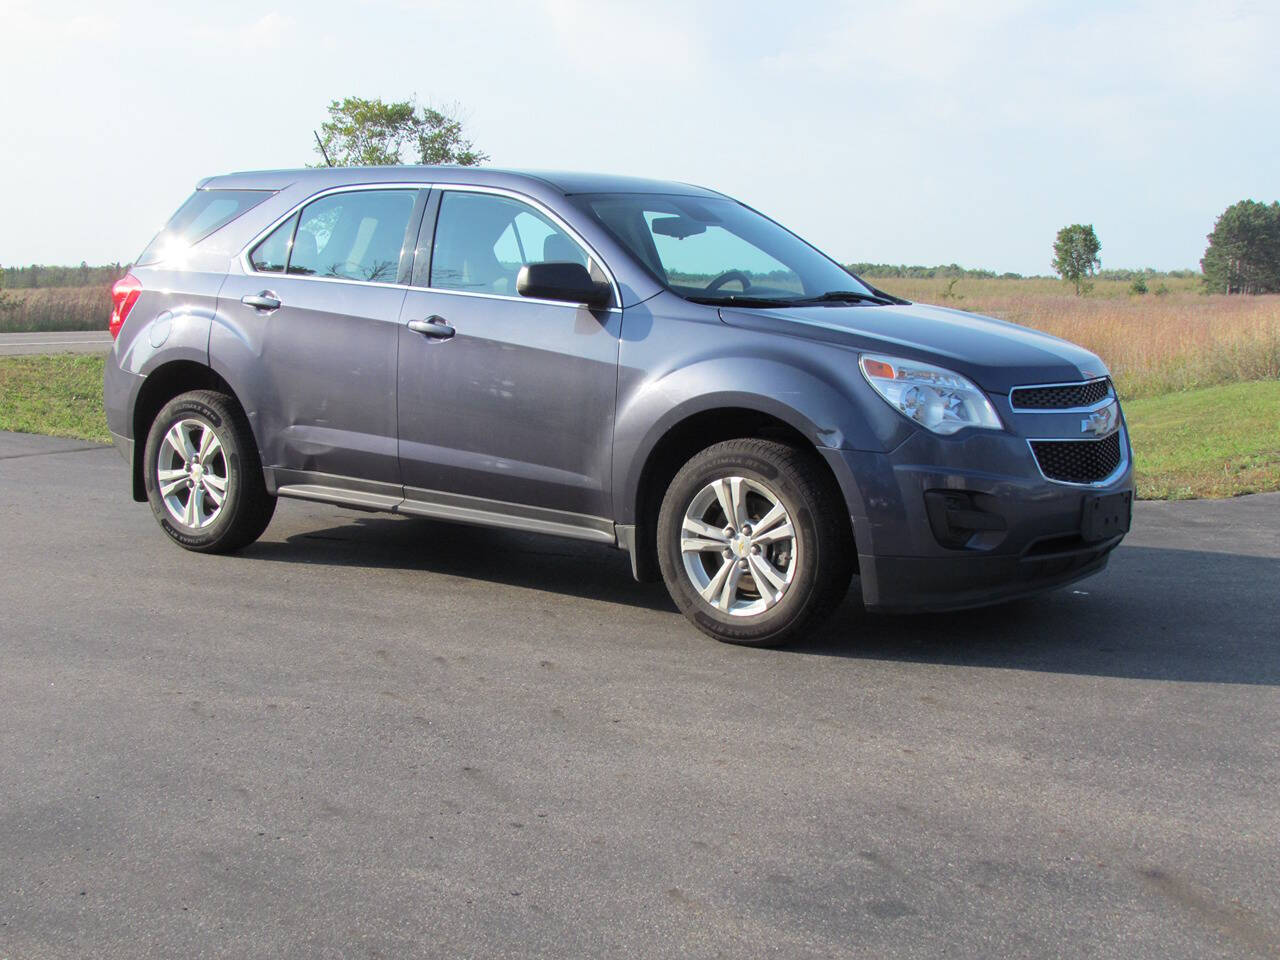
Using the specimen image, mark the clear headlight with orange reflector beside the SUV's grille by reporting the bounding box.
[858,353,1004,434]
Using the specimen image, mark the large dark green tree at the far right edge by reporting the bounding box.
[1201,200,1280,293]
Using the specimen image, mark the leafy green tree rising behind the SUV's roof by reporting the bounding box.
[316,97,489,166]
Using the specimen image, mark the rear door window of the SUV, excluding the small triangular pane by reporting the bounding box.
[285,189,416,283]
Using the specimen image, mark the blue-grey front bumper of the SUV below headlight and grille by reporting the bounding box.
[824,425,1133,612]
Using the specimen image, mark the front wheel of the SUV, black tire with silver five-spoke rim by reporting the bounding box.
[658,438,854,646]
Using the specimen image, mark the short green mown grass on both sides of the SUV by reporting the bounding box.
[0,355,1280,499]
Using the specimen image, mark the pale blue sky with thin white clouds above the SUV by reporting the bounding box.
[0,0,1280,274]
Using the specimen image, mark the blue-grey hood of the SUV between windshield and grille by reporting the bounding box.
[721,303,1107,393]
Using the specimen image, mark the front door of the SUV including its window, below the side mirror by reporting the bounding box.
[398,188,622,540]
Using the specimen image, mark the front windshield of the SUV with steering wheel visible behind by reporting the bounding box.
[581,193,886,306]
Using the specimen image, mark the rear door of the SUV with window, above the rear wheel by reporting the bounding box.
[221,187,426,496]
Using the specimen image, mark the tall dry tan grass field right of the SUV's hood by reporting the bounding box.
[867,276,1280,397]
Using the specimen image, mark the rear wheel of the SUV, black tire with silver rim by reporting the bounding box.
[142,390,275,553]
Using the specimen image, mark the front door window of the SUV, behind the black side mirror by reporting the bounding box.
[428,191,605,297]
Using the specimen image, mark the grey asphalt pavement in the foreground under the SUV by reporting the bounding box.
[0,434,1280,960]
